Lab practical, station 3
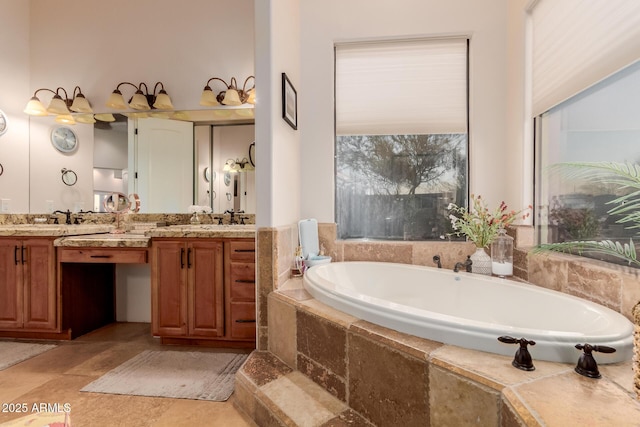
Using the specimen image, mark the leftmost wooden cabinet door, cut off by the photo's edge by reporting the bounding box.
[0,239,22,329]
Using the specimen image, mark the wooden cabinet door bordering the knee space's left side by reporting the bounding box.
[20,239,57,330]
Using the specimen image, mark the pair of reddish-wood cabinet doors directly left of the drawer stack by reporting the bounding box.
[151,239,224,338]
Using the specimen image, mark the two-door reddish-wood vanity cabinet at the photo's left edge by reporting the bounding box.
[0,237,58,332]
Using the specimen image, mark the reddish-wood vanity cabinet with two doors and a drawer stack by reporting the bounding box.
[151,238,256,347]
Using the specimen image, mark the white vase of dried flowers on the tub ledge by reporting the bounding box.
[447,194,531,275]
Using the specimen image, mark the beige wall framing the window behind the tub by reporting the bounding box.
[300,0,516,222]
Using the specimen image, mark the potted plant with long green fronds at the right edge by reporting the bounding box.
[534,162,640,399]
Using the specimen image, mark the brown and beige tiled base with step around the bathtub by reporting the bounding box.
[236,280,640,427]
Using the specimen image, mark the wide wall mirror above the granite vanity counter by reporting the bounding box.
[29,109,255,213]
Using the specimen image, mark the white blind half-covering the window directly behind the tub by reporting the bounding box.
[336,39,467,135]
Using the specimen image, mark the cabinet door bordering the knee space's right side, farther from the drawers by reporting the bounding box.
[151,241,187,336]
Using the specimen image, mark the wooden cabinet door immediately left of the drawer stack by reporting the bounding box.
[187,241,224,337]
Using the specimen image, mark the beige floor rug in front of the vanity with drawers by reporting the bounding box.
[81,350,248,402]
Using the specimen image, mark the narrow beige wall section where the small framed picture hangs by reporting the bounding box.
[255,0,302,227]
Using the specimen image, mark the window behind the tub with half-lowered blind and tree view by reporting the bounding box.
[335,38,468,240]
